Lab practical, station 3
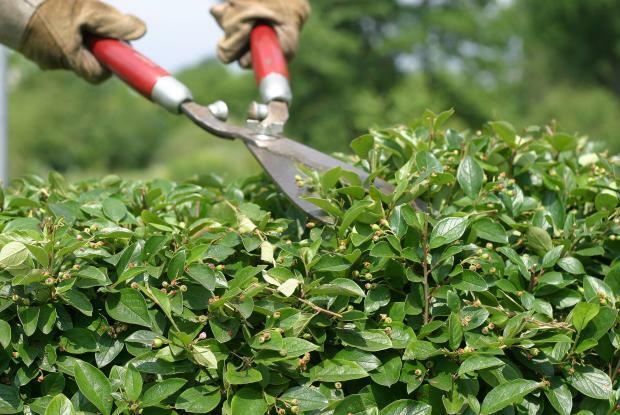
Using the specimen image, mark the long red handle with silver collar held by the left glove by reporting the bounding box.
[86,36,192,113]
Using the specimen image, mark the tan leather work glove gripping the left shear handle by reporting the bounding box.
[20,0,146,83]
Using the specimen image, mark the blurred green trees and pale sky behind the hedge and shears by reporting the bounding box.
[4,0,620,179]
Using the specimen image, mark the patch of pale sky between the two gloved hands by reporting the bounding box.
[106,0,222,71]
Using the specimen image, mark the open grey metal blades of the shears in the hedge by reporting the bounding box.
[245,138,394,224]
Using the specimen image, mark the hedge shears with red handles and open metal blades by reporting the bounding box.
[87,24,426,223]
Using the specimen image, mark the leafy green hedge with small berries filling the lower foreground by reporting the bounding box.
[0,112,620,415]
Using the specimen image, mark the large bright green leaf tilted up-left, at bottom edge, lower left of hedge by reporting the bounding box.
[73,360,113,415]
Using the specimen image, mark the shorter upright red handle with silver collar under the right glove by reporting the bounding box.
[250,23,293,103]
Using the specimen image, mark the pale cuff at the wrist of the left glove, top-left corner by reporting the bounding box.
[0,0,45,50]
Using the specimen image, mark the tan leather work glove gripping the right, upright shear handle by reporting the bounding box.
[211,0,310,68]
